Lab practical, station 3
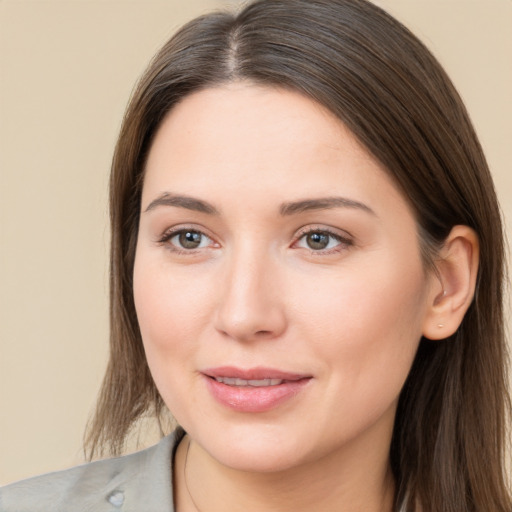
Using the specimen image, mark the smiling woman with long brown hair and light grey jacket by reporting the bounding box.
[0,0,511,512]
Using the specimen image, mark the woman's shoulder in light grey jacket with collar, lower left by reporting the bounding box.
[0,431,183,512]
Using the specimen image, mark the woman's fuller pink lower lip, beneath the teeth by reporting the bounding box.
[205,376,311,412]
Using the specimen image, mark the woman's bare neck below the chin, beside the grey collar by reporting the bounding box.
[174,436,394,512]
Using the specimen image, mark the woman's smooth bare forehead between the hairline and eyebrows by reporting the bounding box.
[143,82,410,218]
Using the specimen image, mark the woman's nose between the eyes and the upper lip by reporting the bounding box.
[215,248,287,341]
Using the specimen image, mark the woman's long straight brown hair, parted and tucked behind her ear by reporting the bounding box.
[86,0,511,512]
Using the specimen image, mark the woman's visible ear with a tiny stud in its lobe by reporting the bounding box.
[423,226,479,340]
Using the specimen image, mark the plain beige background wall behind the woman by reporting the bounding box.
[0,0,512,484]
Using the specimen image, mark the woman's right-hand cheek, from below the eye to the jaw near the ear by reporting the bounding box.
[296,252,427,400]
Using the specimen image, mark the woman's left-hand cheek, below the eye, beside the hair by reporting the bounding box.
[134,254,216,419]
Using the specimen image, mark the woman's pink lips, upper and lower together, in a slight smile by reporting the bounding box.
[201,366,312,413]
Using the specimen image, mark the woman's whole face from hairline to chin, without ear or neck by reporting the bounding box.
[134,83,433,471]
